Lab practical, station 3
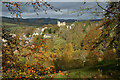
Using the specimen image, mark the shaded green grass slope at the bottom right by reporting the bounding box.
[41,60,120,79]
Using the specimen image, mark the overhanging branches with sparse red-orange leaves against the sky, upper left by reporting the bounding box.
[3,1,60,18]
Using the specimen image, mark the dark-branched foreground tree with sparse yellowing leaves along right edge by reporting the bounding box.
[90,2,120,54]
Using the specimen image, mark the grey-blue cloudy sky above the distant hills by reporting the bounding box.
[2,2,106,20]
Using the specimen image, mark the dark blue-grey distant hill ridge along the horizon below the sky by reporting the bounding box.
[2,17,102,25]
